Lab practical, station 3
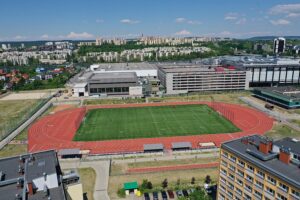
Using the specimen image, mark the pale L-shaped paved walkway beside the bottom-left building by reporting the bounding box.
[60,160,110,200]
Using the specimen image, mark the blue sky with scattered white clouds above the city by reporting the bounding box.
[0,0,300,41]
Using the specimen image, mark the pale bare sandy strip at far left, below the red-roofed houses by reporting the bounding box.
[0,92,50,101]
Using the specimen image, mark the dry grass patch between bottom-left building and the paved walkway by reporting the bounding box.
[78,168,96,200]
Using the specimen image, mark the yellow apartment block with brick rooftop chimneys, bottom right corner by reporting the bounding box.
[217,135,300,200]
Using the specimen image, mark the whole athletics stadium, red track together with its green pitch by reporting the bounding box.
[28,102,273,154]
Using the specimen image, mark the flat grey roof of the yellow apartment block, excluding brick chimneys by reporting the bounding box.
[222,135,300,189]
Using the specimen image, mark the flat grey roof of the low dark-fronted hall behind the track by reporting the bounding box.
[89,72,138,83]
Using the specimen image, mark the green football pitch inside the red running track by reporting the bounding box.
[73,105,239,141]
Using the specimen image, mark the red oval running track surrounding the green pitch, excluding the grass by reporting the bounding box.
[28,102,274,154]
